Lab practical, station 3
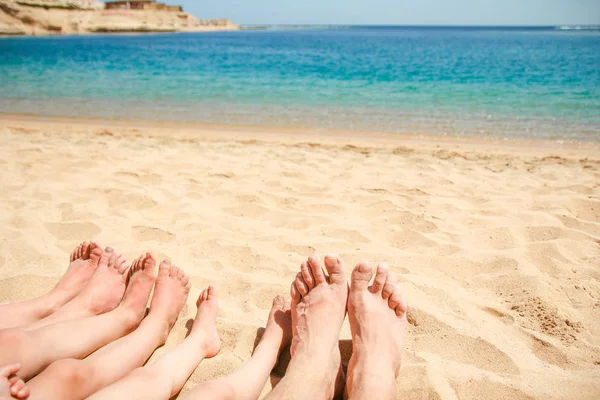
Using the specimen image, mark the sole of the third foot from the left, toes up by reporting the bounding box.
[119,253,156,326]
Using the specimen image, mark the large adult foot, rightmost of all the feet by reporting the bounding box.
[344,262,406,399]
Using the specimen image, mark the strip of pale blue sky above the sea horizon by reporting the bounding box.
[169,0,600,25]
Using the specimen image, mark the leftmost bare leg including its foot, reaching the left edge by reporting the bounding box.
[0,242,102,329]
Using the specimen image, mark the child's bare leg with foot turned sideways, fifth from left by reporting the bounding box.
[90,286,221,400]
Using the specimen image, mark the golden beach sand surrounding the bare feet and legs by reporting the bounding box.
[0,115,600,399]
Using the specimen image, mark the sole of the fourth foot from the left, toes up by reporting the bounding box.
[148,260,192,341]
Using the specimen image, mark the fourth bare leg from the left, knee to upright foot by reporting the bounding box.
[27,259,190,400]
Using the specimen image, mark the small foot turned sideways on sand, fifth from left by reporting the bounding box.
[190,286,221,358]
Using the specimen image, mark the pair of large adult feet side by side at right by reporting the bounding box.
[291,255,407,399]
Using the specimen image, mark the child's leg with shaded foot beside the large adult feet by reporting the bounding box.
[182,296,292,400]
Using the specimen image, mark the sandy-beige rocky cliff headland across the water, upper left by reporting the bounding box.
[0,0,239,35]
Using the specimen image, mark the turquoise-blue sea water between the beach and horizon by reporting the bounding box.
[0,27,600,141]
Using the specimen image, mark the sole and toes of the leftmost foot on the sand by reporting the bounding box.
[49,242,102,307]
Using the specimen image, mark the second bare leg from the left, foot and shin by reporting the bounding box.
[25,247,130,330]
